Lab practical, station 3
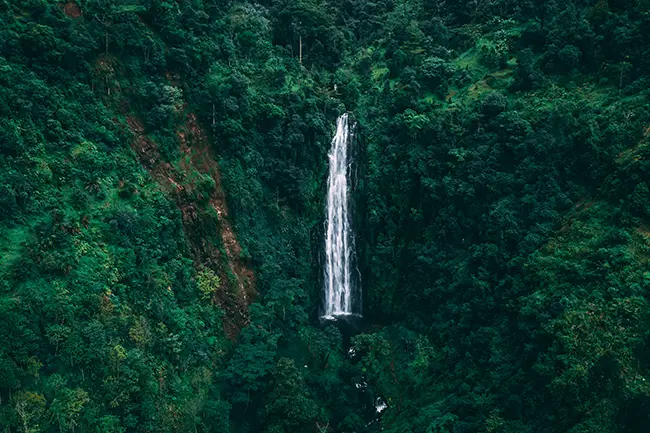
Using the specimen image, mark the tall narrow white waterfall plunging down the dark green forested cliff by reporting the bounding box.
[323,113,361,320]
